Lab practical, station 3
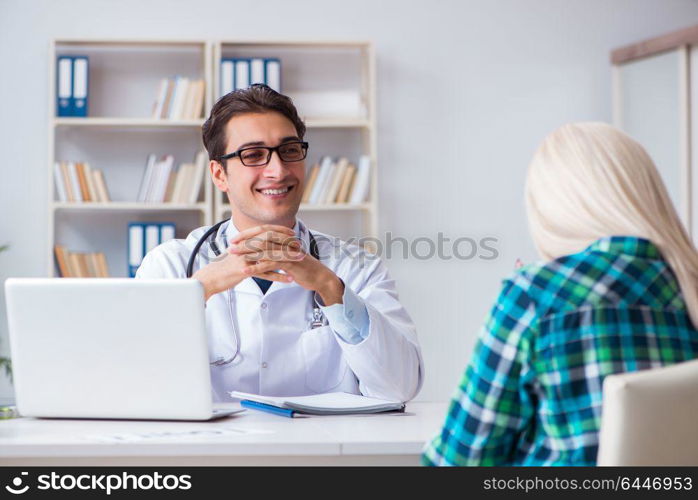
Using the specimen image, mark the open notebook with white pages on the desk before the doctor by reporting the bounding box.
[230,391,405,415]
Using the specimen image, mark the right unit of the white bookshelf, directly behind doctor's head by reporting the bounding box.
[213,40,378,238]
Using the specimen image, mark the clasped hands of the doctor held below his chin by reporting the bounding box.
[193,224,344,306]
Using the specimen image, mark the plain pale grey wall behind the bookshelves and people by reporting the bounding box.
[0,0,698,400]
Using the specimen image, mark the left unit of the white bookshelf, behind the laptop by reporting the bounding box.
[47,39,213,277]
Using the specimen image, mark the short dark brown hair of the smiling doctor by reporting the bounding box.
[201,83,305,166]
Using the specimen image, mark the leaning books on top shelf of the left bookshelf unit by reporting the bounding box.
[153,76,206,120]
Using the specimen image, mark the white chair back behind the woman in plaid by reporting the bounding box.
[597,360,698,466]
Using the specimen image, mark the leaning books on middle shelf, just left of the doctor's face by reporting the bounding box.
[137,151,207,204]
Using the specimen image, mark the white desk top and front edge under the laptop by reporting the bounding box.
[0,403,447,466]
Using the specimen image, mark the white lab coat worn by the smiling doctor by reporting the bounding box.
[136,221,424,401]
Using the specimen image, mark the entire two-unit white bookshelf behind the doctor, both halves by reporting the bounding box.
[47,39,378,282]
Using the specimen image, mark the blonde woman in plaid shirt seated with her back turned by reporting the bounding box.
[423,123,698,465]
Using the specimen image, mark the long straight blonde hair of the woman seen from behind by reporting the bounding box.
[526,123,698,327]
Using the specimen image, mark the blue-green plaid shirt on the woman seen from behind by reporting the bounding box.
[422,236,698,465]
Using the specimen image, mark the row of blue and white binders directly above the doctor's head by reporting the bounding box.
[220,57,281,97]
